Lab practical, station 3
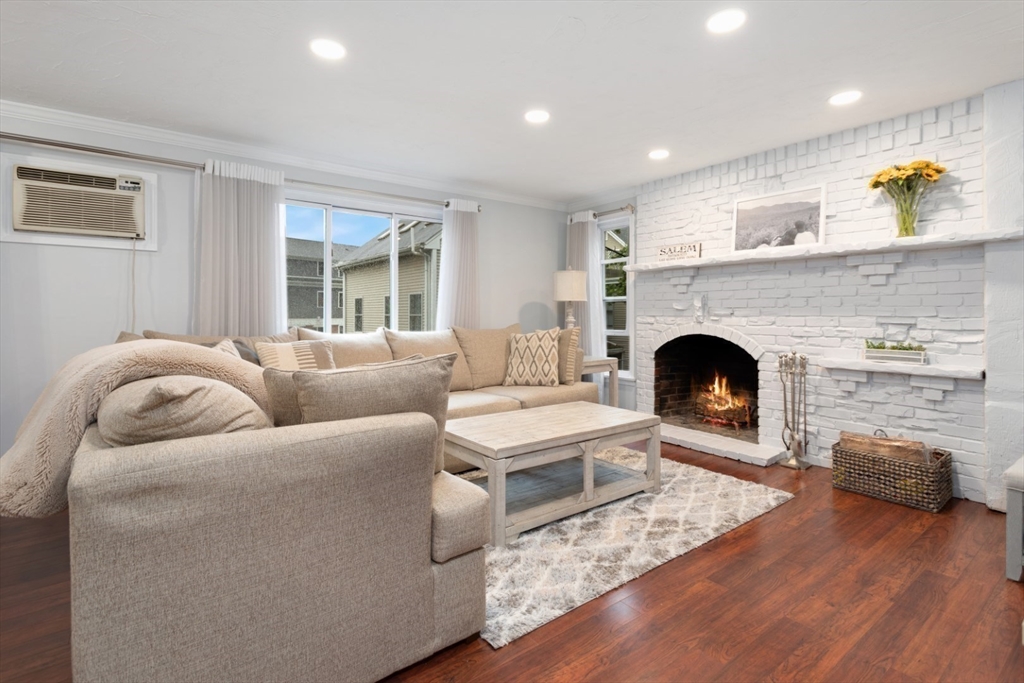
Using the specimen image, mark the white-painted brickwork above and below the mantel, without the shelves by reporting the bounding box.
[635,97,985,501]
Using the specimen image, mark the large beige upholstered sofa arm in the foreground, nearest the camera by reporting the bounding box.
[69,414,437,681]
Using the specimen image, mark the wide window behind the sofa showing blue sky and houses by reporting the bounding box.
[285,190,441,333]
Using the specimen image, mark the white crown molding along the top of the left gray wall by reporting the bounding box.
[0,99,566,211]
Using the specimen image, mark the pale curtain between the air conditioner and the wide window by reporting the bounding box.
[193,161,287,336]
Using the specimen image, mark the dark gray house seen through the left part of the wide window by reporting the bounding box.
[286,238,358,332]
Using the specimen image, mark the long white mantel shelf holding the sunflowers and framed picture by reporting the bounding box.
[625,229,1024,274]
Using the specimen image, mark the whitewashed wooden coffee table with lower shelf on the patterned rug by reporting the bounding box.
[444,401,662,546]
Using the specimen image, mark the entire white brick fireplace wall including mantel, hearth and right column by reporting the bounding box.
[618,81,1024,509]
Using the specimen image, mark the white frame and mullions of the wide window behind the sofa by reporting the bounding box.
[281,187,444,332]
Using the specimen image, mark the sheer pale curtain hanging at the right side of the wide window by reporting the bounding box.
[436,200,480,330]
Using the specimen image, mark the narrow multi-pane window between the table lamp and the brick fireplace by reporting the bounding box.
[597,213,633,377]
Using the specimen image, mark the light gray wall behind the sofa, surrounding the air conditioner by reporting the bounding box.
[0,118,565,453]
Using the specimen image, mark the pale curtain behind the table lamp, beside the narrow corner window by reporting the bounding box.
[565,211,608,356]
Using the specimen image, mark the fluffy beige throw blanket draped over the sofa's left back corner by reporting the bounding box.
[0,339,270,517]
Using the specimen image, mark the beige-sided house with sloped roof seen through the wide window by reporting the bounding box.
[337,220,441,332]
